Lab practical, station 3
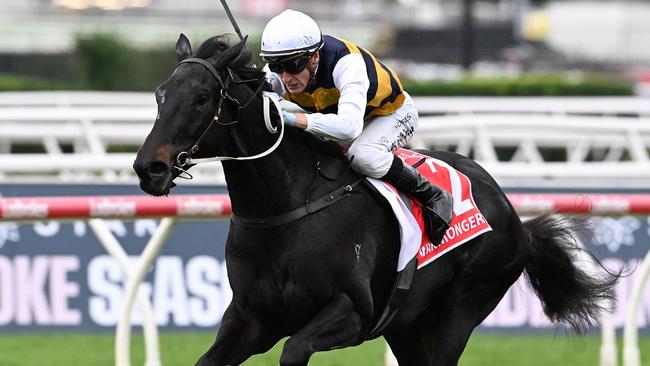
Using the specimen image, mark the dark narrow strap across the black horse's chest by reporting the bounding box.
[230,178,365,228]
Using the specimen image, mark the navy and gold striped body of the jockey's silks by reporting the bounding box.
[284,35,404,117]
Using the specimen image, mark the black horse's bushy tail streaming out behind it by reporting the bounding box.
[524,214,620,333]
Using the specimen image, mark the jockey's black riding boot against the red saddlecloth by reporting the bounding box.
[382,156,453,246]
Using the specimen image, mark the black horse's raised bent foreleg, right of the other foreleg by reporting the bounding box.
[280,293,362,366]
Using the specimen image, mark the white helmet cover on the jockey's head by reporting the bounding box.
[260,9,323,58]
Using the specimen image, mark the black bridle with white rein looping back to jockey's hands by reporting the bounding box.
[173,57,284,179]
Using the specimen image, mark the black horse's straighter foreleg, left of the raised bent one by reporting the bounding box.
[196,301,280,366]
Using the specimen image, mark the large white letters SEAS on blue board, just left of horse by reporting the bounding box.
[88,255,232,327]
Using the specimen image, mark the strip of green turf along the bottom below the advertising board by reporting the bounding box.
[0,333,650,366]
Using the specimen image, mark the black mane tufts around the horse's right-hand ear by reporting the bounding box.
[194,33,264,79]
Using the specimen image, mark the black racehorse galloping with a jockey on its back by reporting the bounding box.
[134,35,617,366]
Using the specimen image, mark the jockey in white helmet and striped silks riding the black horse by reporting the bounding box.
[260,9,452,245]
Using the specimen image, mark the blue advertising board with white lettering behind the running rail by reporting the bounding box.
[0,184,650,332]
